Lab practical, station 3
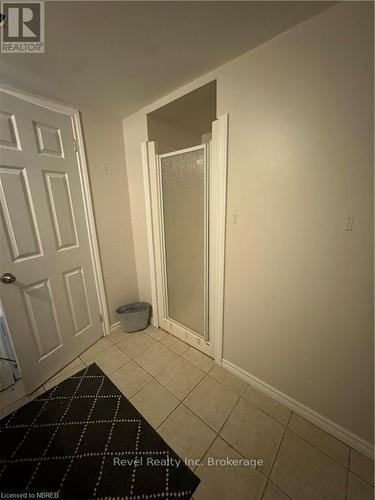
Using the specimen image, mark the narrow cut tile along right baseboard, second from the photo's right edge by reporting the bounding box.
[289,413,350,467]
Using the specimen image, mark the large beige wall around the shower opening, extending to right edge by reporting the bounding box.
[124,2,374,441]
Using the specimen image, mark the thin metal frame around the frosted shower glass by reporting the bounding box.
[156,143,210,343]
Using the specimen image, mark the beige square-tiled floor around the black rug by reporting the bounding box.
[0,326,374,500]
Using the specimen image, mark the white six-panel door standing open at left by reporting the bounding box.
[0,92,103,392]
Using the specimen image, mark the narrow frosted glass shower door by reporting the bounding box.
[159,145,208,340]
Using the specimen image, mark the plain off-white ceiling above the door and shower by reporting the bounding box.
[0,1,335,117]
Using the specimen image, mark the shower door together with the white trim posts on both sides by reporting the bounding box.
[142,115,227,360]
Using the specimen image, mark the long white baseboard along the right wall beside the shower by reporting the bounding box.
[222,359,374,459]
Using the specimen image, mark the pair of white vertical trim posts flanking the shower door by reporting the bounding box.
[142,114,228,365]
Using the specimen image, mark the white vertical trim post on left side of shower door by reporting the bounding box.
[141,142,159,328]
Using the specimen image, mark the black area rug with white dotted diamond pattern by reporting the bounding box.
[0,364,199,500]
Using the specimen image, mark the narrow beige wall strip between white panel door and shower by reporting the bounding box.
[82,111,138,324]
